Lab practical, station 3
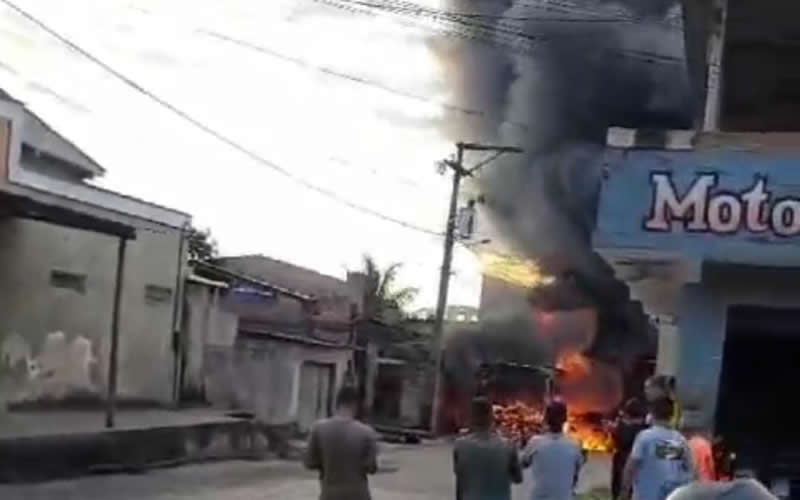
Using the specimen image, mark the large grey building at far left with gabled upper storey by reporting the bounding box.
[0,91,190,413]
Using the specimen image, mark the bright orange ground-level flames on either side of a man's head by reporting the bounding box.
[493,401,614,453]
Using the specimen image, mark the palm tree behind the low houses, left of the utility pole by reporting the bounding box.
[362,255,419,320]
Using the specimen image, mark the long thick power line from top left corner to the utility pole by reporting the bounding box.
[0,0,443,236]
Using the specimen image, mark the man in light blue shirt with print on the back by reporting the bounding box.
[623,398,694,500]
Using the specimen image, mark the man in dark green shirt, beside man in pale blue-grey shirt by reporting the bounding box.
[453,397,522,500]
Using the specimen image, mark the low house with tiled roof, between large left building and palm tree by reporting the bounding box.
[182,256,361,433]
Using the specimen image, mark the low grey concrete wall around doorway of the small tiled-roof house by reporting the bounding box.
[205,337,352,425]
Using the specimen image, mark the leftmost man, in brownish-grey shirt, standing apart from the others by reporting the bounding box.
[305,386,378,500]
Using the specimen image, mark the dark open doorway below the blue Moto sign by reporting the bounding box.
[716,306,800,484]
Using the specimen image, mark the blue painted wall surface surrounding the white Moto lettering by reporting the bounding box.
[593,150,800,266]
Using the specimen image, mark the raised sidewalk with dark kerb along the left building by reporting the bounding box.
[0,409,266,482]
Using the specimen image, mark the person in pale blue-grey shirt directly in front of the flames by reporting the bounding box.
[522,401,584,500]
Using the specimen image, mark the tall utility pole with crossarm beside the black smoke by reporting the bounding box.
[430,142,522,435]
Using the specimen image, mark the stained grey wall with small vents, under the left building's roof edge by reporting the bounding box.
[0,218,181,411]
